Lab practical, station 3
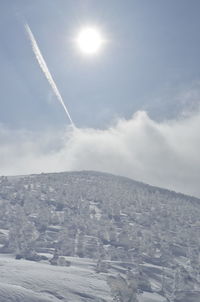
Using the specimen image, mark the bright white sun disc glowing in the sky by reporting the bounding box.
[76,26,104,55]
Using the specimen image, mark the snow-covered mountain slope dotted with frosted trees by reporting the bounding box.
[0,171,200,302]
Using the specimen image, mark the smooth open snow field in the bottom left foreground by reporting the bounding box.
[0,255,112,302]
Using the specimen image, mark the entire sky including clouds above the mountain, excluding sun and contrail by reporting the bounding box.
[0,0,200,197]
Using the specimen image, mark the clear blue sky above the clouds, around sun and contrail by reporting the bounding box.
[0,0,200,129]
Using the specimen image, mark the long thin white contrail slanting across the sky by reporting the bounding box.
[25,24,74,126]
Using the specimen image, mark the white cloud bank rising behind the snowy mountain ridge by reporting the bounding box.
[0,112,200,197]
